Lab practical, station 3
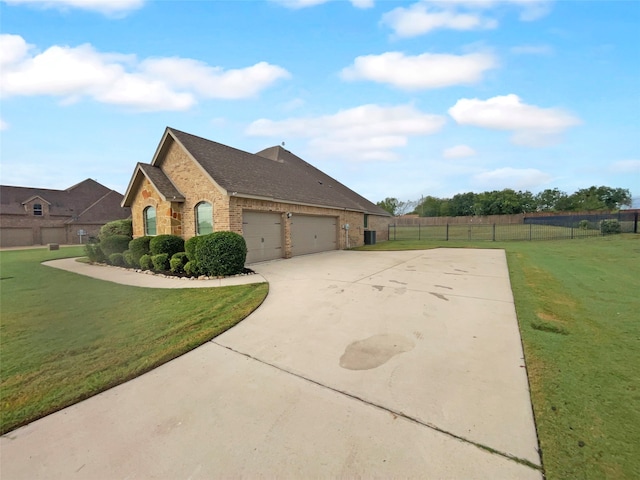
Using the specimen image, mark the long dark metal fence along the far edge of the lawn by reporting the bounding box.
[389,219,638,242]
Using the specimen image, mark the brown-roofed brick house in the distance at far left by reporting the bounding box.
[0,179,131,247]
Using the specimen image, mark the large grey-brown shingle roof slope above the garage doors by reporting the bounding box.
[166,128,389,216]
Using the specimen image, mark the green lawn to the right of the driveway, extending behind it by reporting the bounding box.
[362,234,640,480]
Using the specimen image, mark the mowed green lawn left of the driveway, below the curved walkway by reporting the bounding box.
[0,247,268,433]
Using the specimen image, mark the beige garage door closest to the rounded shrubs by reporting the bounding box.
[242,212,284,263]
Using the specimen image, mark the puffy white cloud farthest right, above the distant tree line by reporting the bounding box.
[449,94,581,147]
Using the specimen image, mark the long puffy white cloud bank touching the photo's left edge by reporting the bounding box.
[0,34,290,111]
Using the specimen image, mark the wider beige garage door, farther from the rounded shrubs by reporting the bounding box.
[291,215,338,255]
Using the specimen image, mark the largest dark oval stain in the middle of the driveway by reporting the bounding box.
[340,334,416,370]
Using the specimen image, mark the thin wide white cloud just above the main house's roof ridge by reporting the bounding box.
[246,104,446,161]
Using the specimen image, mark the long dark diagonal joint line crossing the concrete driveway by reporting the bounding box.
[210,342,542,471]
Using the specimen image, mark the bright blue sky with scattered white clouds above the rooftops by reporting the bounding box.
[0,0,640,202]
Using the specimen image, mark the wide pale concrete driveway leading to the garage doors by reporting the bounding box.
[1,249,542,479]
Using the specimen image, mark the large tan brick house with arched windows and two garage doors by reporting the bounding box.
[122,128,390,263]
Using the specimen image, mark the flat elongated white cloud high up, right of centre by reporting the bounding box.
[341,52,497,90]
